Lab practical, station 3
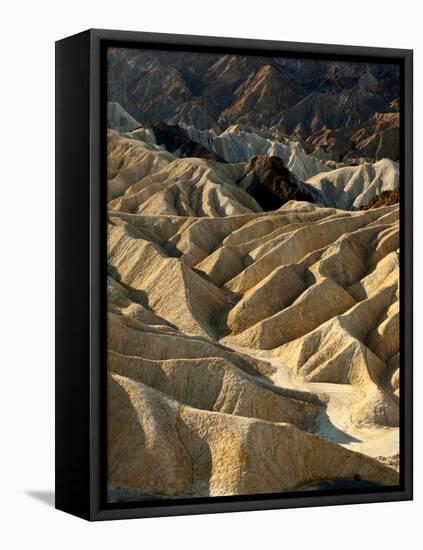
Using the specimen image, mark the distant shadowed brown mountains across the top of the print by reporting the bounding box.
[108,48,399,160]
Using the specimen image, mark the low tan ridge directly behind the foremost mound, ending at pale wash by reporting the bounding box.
[108,351,322,428]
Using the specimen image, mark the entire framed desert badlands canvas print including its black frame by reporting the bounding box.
[56,30,412,520]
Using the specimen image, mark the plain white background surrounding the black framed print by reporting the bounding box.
[0,0,423,550]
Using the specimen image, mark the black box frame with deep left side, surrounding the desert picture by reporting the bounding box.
[55,29,413,521]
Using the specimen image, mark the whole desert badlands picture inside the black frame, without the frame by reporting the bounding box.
[107,50,400,501]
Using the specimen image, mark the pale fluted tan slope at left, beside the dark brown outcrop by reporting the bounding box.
[108,133,261,216]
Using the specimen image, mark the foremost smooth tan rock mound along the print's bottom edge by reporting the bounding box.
[108,375,398,497]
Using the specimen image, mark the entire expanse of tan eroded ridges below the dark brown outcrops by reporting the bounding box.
[107,129,400,504]
